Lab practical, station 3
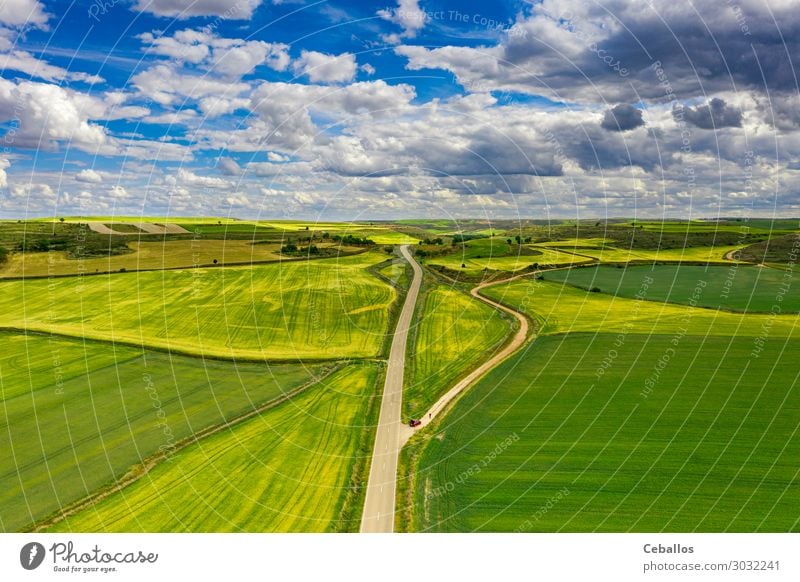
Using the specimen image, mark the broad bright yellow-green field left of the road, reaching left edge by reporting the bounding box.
[0,253,397,361]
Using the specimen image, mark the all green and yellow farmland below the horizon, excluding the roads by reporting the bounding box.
[0,217,800,532]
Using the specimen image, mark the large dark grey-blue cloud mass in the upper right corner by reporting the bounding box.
[396,0,800,103]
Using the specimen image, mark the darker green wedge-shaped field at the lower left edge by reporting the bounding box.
[0,333,325,531]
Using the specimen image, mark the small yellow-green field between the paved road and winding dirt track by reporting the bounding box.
[403,286,511,418]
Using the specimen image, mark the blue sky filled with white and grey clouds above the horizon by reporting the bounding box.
[0,0,800,220]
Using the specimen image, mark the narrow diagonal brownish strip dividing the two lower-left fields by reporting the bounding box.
[28,362,348,533]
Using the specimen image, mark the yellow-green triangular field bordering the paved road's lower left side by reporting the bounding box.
[54,365,379,532]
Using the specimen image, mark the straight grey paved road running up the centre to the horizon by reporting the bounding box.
[361,246,422,533]
